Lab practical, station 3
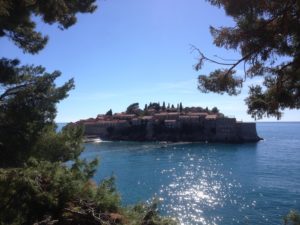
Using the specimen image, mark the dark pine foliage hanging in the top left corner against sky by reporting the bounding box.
[0,0,96,54]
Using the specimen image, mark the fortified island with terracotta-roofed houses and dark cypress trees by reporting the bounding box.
[76,103,262,143]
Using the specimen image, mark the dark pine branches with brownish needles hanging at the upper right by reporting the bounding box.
[195,0,300,119]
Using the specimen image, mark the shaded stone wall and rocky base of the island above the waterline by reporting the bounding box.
[85,118,260,143]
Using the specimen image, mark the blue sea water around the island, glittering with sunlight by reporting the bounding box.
[82,123,300,225]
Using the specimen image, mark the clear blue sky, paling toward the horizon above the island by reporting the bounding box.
[0,0,300,122]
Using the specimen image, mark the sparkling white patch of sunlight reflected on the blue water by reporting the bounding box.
[159,149,240,225]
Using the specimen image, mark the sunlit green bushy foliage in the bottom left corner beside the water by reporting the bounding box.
[0,159,177,225]
